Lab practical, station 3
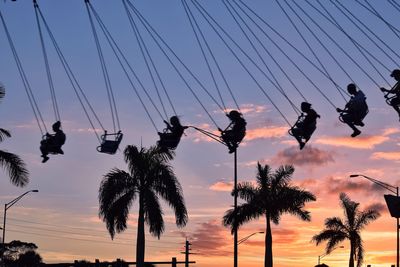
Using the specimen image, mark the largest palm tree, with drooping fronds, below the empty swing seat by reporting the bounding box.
[99,145,188,267]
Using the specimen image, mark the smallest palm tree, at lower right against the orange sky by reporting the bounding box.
[312,193,380,267]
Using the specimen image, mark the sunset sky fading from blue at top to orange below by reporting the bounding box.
[0,0,400,267]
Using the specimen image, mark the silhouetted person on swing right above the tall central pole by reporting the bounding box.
[218,110,246,153]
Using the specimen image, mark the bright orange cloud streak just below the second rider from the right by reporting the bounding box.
[315,128,400,149]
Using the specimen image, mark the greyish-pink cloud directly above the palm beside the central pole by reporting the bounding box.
[272,146,335,166]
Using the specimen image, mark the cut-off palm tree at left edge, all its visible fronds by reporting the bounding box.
[0,84,29,187]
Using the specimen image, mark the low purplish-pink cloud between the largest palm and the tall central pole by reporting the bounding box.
[184,220,232,256]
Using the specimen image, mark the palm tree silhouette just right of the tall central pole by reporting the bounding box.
[223,163,315,267]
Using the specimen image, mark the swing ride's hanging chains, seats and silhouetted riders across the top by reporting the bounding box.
[1,0,400,162]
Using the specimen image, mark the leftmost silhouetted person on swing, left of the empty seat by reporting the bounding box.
[40,121,66,163]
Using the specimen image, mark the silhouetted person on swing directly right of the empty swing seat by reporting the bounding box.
[157,116,188,150]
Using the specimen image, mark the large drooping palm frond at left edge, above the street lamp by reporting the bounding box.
[0,150,29,187]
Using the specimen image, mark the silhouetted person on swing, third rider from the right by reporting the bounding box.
[291,102,321,150]
